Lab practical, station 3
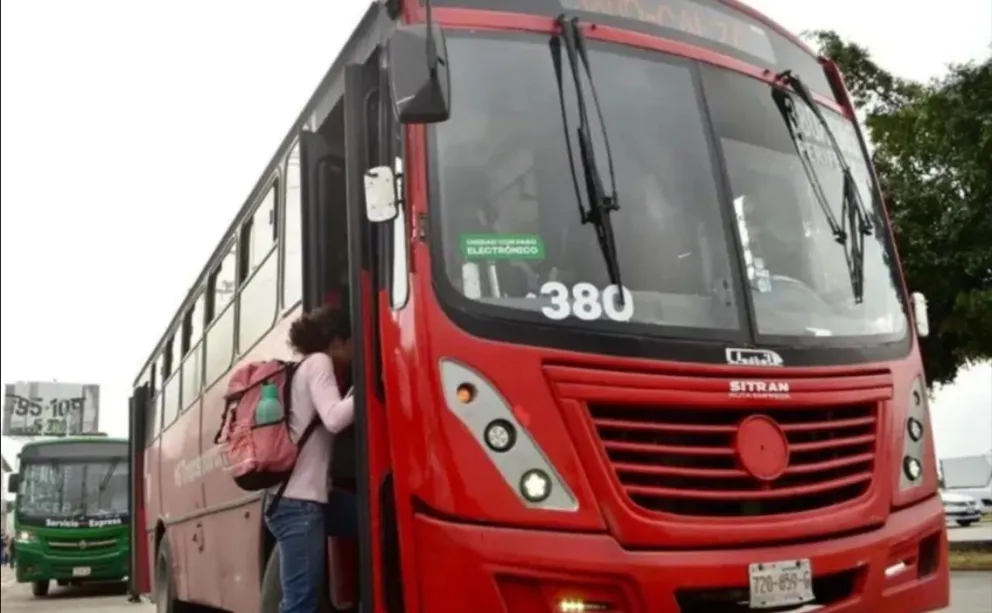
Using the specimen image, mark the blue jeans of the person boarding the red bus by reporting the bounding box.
[265,490,358,613]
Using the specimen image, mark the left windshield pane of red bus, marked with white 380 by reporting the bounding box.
[434,35,741,335]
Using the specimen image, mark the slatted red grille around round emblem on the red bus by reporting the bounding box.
[587,403,878,517]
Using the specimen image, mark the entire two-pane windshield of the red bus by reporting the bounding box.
[431,32,905,340]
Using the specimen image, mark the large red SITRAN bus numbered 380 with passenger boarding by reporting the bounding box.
[132,0,949,613]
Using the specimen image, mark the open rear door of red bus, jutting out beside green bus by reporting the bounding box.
[127,384,151,602]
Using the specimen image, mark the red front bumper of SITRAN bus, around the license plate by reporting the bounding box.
[414,497,950,613]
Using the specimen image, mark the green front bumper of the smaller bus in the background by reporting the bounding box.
[15,546,130,583]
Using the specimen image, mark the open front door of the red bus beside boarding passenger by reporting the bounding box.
[300,53,395,612]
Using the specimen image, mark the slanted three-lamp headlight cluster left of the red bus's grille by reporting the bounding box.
[440,359,579,511]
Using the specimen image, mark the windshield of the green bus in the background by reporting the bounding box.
[17,458,129,519]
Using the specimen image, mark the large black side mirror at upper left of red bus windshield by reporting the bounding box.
[387,24,451,124]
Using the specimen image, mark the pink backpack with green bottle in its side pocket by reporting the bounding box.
[214,360,318,512]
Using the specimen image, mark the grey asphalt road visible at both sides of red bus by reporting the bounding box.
[0,572,992,613]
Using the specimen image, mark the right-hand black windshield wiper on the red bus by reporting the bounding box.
[772,70,874,304]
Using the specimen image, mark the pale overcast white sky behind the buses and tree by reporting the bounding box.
[0,0,992,456]
